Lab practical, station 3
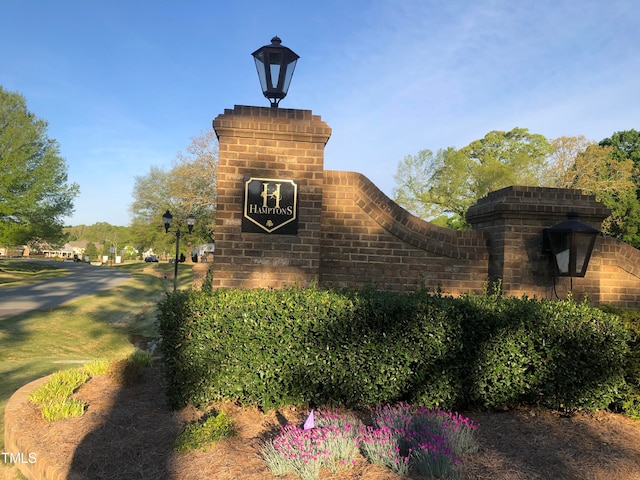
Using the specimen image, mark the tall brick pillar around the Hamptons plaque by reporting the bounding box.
[213,105,331,288]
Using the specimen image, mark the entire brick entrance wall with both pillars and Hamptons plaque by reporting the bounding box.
[213,106,640,307]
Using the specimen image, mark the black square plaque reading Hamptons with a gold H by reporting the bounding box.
[242,177,298,235]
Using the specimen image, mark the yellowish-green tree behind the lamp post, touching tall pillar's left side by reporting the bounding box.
[130,130,218,252]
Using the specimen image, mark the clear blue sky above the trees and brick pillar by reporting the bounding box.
[0,0,640,225]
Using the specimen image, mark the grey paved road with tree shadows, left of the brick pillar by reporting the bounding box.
[0,260,131,320]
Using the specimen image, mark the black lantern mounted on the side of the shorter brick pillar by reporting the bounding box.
[544,212,600,277]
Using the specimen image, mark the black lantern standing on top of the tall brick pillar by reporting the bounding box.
[251,37,300,108]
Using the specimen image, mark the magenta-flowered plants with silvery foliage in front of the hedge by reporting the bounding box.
[261,404,476,480]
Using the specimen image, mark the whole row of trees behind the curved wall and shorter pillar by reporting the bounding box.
[393,127,640,248]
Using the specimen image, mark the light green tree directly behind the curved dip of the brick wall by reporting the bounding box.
[394,128,552,228]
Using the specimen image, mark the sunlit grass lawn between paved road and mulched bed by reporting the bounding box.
[0,261,191,478]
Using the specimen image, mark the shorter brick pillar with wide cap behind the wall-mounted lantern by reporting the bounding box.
[467,186,609,303]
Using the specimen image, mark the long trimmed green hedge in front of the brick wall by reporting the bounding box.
[159,288,628,410]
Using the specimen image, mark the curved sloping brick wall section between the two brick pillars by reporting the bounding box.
[320,170,489,294]
